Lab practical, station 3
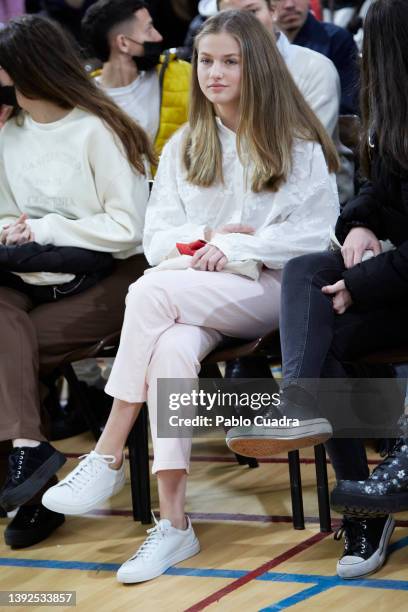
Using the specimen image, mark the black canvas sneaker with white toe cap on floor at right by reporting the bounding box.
[334,516,395,579]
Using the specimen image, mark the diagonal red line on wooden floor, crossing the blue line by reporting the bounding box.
[184,533,330,612]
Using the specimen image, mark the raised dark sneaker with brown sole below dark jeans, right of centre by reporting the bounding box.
[226,396,333,457]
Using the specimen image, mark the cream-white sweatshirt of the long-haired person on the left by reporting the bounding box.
[0,108,149,259]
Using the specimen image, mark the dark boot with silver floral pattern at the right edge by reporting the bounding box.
[330,438,408,516]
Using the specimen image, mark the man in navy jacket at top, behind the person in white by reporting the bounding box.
[274,0,358,115]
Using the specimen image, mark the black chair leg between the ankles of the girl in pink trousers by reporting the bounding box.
[128,405,152,525]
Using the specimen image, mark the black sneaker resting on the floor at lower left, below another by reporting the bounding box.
[4,504,65,548]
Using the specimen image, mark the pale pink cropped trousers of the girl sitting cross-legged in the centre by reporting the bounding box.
[105,269,281,473]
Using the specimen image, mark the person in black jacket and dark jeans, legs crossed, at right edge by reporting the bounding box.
[227,0,408,578]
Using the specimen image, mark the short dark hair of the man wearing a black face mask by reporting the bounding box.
[81,0,149,62]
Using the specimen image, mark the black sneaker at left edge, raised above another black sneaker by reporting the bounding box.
[0,442,66,512]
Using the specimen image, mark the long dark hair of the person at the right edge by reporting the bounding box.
[361,0,408,176]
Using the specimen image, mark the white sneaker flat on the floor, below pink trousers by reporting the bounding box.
[116,517,200,584]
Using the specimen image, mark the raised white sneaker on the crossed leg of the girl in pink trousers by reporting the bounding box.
[42,451,126,515]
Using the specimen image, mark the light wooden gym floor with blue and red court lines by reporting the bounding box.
[0,434,408,612]
